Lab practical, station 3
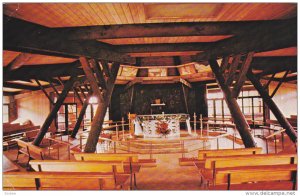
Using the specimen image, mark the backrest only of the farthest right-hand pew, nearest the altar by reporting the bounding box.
[198,148,262,160]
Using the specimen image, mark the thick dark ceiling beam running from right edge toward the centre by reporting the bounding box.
[192,18,297,62]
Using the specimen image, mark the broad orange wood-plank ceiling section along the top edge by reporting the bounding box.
[3,3,297,27]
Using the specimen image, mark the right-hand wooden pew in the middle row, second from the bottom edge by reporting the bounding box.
[195,154,297,184]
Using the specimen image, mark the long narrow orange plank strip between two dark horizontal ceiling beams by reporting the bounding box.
[98,35,233,45]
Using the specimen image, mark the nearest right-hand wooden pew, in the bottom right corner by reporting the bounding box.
[209,164,297,190]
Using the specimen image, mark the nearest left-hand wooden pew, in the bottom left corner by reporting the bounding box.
[3,172,128,190]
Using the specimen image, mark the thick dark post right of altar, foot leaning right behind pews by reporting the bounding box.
[209,60,256,148]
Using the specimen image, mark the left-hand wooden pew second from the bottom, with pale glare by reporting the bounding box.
[29,160,130,189]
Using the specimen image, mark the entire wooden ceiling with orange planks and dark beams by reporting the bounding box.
[3,3,297,94]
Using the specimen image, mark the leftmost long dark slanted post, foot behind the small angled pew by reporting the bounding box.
[33,76,77,146]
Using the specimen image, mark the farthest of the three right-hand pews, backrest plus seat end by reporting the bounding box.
[179,148,262,166]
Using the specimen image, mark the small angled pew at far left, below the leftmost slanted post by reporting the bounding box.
[15,139,47,165]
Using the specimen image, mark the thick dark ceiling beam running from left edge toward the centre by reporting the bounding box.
[3,15,135,63]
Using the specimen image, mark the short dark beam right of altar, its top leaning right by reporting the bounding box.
[232,52,254,98]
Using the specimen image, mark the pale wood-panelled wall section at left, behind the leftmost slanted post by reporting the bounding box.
[16,93,50,125]
